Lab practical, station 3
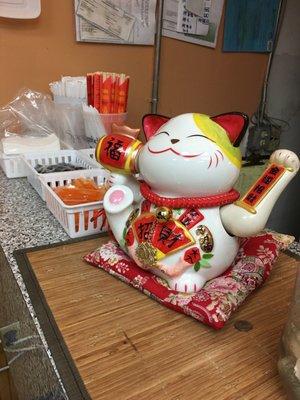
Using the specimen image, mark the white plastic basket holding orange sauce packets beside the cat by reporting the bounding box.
[42,169,107,238]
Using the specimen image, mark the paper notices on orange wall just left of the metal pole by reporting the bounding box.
[75,0,156,45]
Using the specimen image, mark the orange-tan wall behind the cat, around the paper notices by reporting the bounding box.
[0,0,266,125]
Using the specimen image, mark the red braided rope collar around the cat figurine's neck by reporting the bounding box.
[140,182,240,208]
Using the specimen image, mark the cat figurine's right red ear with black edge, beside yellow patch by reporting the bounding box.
[211,112,249,147]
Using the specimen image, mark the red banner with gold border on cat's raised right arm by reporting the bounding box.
[238,164,285,209]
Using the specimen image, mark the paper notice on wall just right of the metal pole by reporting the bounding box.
[162,0,224,47]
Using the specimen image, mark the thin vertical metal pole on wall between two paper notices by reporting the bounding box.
[151,0,164,114]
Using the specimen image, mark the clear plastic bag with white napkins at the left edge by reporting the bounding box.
[0,89,60,155]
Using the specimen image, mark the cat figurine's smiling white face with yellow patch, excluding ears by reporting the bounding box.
[138,114,241,197]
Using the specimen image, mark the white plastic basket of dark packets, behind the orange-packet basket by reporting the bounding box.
[22,150,100,200]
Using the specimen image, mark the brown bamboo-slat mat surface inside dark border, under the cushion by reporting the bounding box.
[27,239,297,400]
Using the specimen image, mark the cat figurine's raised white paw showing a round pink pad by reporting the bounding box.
[103,185,133,214]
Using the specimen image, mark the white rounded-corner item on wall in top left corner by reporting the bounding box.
[0,0,41,19]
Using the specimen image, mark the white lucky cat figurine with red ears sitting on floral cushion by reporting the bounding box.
[96,113,299,292]
